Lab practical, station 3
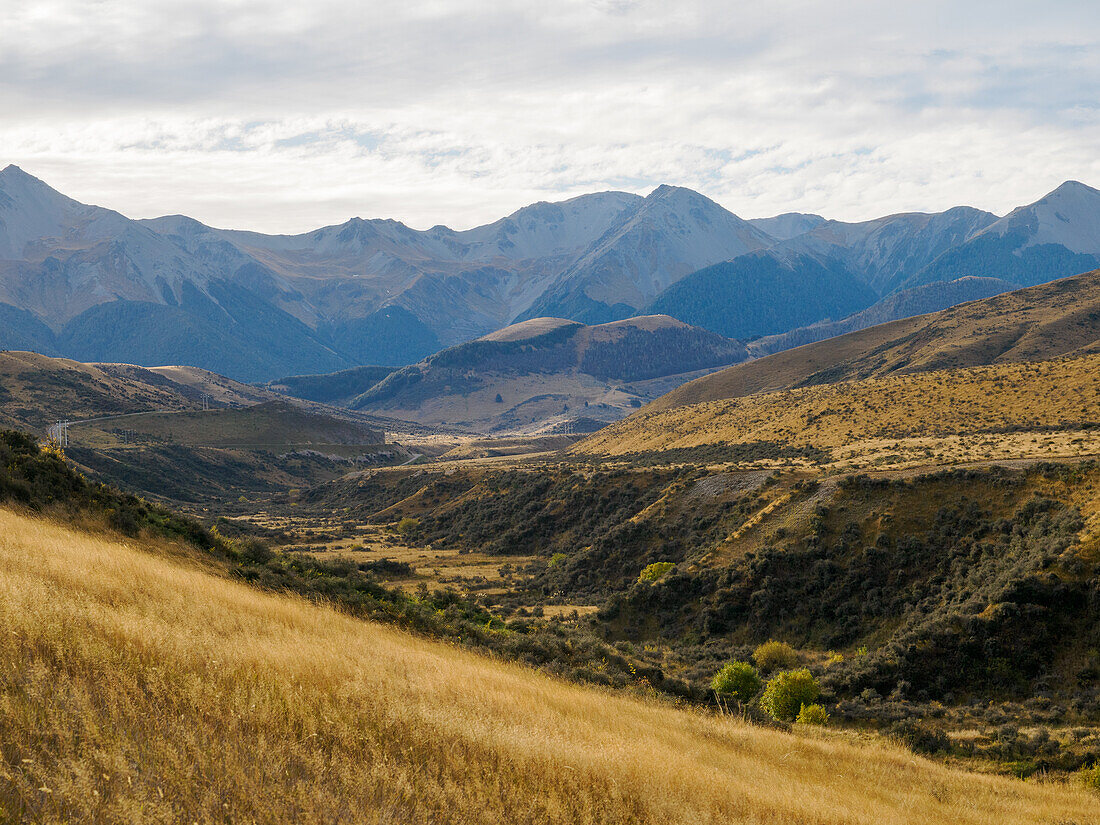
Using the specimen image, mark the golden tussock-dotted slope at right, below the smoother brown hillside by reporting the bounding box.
[573,355,1100,468]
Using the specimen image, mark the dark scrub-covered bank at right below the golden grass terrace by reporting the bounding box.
[301,461,1100,776]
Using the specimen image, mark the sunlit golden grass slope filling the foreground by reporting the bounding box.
[0,510,1100,825]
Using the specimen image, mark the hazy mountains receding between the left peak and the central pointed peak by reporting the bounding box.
[144,191,642,349]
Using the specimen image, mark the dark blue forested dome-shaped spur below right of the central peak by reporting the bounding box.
[645,251,877,339]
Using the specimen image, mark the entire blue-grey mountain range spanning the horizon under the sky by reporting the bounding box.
[0,166,1100,381]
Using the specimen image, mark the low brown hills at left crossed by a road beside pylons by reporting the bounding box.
[0,352,411,504]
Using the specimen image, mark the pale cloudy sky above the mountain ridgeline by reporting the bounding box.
[0,0,1100,232]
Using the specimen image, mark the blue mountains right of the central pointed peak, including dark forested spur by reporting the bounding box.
[642,182,1100,345]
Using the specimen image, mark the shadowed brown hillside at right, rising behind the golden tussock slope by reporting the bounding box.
[652,270,1100,409]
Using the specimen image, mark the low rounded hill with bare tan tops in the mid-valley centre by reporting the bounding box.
[350,316,747,431]
